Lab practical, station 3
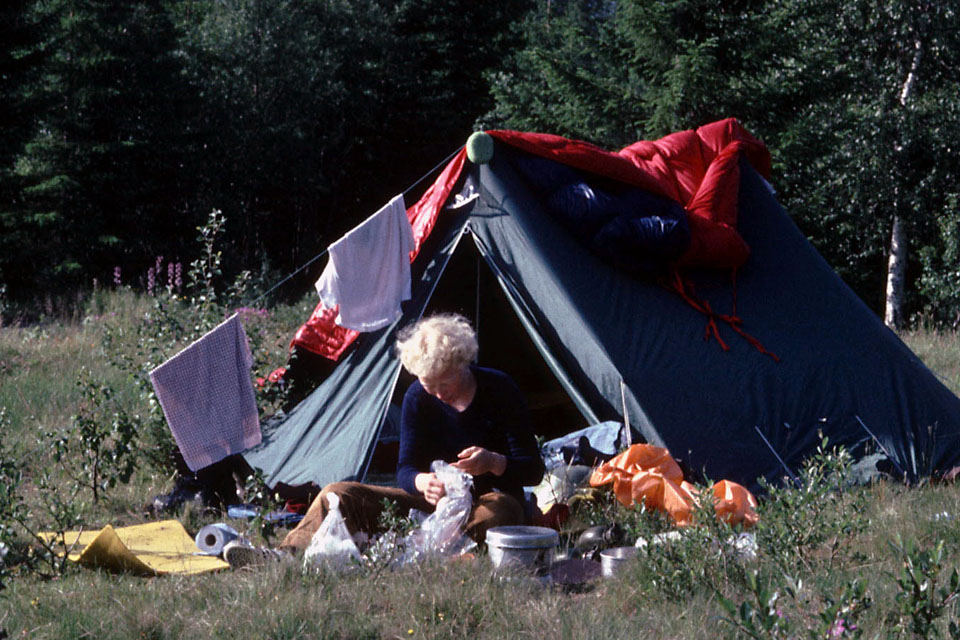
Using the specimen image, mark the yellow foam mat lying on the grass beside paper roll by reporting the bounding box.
[40,520,230,576]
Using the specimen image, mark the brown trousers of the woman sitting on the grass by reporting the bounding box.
[280,482,526,551]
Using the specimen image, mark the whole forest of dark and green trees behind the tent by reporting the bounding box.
[0,0,960,328]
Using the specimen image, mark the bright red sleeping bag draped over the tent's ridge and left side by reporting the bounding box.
[290,118,770,360]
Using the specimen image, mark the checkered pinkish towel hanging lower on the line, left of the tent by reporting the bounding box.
[150,314,260,471]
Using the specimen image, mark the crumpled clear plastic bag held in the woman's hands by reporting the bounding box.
[401,460,477,563]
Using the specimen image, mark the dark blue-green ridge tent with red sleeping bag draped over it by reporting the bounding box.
[244,119,960,489]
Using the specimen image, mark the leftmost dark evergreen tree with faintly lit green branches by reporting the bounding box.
[13,0,195,290]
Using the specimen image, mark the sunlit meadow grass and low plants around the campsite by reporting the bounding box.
[7,290,960,639]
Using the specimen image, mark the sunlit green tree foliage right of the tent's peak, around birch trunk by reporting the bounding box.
[486,0,960,319]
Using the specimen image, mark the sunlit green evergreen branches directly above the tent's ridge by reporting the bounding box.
[485,0,813,148]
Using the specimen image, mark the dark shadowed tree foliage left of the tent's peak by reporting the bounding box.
[0,0,525,310]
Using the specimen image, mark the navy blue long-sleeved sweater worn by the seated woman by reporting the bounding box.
[397,366,544,502]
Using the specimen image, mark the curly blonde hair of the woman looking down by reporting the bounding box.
[396,313,480,378]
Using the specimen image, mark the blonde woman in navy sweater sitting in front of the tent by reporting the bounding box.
[281,314,544,551]
